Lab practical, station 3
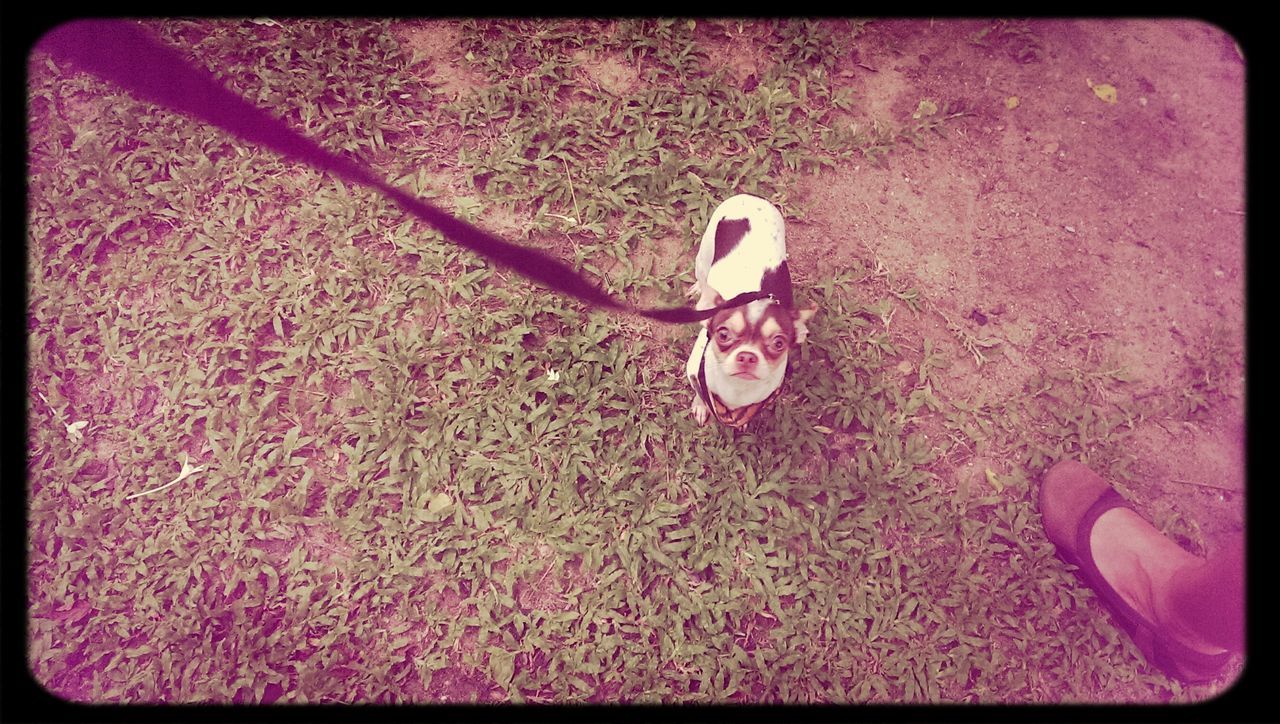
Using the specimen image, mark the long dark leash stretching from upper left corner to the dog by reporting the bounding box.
[36,20,765,324]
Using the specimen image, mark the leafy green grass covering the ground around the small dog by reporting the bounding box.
[27,20,1213,702]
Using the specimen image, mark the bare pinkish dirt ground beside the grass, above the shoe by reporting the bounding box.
[787,20,1245,549]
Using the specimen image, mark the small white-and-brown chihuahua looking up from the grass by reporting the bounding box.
[685,193,818,429]
